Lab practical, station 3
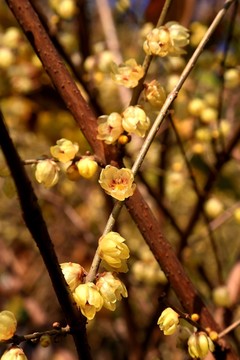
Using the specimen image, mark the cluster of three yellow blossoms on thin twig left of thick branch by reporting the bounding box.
[35,138,98,188]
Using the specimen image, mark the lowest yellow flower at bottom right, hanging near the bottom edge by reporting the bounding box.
[188,332,214,359]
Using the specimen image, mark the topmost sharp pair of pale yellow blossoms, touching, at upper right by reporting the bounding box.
[143,21,189,57]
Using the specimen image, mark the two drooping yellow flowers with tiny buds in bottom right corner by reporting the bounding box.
[157,307,217,359]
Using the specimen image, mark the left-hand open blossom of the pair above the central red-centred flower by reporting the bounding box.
[97,112,124,144]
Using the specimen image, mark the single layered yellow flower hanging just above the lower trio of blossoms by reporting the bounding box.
[97,231,130,272]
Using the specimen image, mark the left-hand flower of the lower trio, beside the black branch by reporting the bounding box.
[60,262,86,291]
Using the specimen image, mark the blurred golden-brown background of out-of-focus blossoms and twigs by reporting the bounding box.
[0,0,240,360]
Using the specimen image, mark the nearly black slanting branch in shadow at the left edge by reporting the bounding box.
[0,111,91,360]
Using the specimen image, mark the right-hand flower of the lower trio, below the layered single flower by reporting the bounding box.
[96,272,128,311]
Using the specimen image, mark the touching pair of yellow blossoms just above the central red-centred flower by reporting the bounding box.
[97,106,150,144]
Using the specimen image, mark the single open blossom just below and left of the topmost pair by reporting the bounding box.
[111,59,144,88]
